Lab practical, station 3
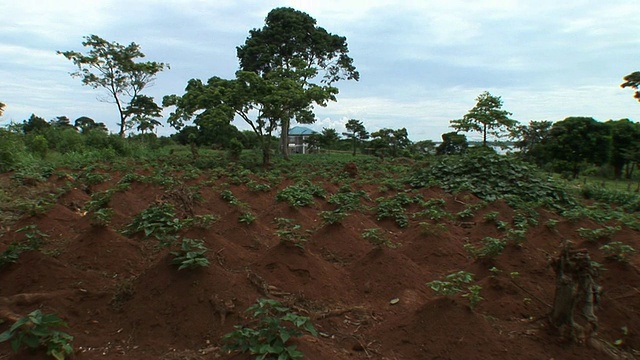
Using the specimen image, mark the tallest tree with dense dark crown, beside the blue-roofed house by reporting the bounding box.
[237,7,360,158]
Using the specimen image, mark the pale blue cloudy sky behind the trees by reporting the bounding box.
[0,0,640,141]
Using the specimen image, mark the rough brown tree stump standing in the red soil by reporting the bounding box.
[550,241,600,341]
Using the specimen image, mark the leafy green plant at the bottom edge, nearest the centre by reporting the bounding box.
[223,299,318,360]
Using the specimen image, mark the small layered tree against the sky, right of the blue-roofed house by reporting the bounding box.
[451,91,516,146]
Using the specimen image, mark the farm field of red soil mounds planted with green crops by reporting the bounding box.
[0,150,640,360]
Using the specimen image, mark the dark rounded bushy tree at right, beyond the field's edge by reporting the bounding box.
[544,117,611,179]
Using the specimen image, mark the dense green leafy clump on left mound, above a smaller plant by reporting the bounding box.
[123,203,182,245]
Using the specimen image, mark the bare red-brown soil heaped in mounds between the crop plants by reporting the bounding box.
[0,169,640,360]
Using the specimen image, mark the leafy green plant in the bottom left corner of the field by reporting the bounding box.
[0,310,73,360]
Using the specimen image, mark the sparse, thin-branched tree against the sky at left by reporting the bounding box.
[58,35,169,137]
